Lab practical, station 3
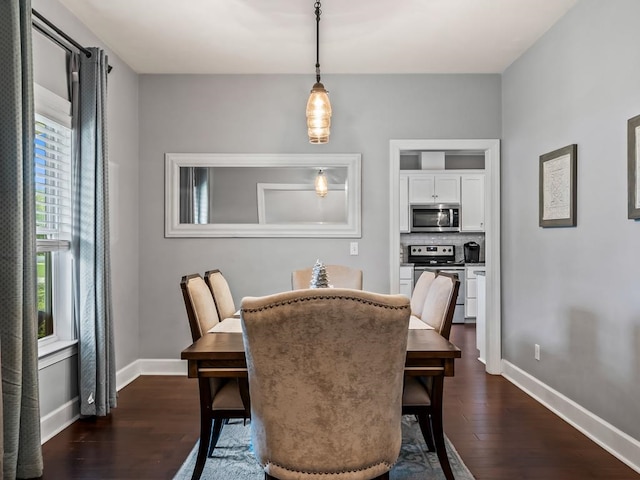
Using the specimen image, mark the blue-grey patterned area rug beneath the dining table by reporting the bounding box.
[173,416,474,480]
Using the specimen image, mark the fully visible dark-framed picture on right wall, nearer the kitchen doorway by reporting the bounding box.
[540,144,578,227]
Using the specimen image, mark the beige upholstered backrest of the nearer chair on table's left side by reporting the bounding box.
[180,273,220,342]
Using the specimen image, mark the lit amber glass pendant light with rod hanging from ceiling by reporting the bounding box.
[307,2,331,143]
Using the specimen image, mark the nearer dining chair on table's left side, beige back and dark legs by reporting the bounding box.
[180,273,250,480]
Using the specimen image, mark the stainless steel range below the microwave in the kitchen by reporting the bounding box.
[408,245,465,323]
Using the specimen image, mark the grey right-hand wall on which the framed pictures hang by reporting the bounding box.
[502,0,640,438]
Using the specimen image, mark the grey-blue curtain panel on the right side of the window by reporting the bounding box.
[72,48,117,416]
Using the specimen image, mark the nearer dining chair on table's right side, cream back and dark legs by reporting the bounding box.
[402,272,460,480]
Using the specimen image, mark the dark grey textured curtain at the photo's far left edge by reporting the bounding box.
[0,0,42,480]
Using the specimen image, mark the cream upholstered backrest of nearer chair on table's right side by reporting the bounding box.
[420,272,460,339]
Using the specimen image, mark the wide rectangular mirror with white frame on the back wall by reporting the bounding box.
[165,153,361,238]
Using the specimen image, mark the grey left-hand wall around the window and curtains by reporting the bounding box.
[32,0,140,415]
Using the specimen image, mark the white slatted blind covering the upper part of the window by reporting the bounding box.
[34,113,71,252]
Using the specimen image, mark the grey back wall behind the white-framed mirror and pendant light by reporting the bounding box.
[140,74,501,358]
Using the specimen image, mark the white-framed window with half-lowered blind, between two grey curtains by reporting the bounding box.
[34,85,73,347]
